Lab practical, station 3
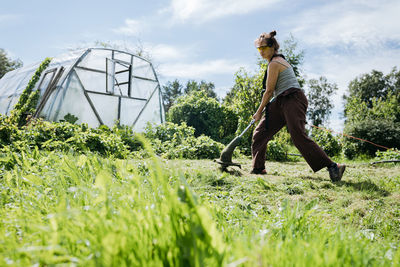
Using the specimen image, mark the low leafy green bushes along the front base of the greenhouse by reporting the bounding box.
[0,116,130,158]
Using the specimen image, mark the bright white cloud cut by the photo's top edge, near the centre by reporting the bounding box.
[167,0,280,23]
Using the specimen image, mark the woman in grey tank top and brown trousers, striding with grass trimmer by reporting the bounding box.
[251,31,346,182]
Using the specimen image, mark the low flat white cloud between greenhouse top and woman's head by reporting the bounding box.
[160,59,247,79]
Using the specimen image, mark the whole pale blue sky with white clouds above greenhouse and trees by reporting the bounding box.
[0,0,400,131]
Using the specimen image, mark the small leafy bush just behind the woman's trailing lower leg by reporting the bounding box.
[311,128,342,157]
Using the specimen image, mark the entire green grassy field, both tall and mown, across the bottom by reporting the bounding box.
[0,150,400,266]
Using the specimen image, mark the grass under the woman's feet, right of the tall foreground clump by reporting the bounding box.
[166,159,400,266]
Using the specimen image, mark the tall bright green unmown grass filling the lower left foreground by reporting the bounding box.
[0,139,225,266]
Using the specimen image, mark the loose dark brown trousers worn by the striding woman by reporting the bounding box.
[251,89,333,172]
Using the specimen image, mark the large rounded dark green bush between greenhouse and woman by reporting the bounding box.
[167,91,238,143]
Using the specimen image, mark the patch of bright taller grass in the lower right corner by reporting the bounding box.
[220,201,399,266]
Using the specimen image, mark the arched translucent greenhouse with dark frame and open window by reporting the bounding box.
[0,48,165,131]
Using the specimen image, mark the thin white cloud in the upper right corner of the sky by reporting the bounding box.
[286,0,400,49]
